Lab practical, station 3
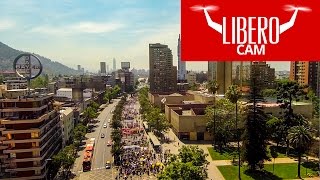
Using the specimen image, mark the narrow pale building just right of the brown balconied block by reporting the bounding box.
[60,107,74,147]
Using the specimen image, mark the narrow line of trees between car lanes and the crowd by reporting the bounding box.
[111,95,127,165]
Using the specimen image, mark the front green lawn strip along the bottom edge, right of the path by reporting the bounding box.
[218,163,316,180]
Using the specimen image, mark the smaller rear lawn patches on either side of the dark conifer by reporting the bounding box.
[208,146,287,160]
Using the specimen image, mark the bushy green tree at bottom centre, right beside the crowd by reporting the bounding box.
[158,146,209,180]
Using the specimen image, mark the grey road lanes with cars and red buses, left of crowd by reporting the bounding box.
[72,99,119,175]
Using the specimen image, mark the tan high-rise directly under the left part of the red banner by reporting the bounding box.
[208,61,251,94]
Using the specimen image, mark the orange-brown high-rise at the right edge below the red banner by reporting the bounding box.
[290,61,319,92]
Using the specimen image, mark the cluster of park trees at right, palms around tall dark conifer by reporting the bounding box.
[206,74,319,178]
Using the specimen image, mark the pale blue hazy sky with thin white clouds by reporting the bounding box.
[0,0,289,72]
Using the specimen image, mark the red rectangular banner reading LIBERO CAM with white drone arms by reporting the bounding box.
[181,0,320,61]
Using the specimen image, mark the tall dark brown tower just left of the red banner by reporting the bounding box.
[149,43,177,93]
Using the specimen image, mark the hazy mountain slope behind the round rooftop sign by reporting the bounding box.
[0,42,79,75]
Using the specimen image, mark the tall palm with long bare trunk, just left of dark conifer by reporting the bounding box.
[226,85,241,179]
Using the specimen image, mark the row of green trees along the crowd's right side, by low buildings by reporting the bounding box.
[139,87,170,137]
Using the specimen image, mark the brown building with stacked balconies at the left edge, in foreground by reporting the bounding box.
[0,90,62,180]
